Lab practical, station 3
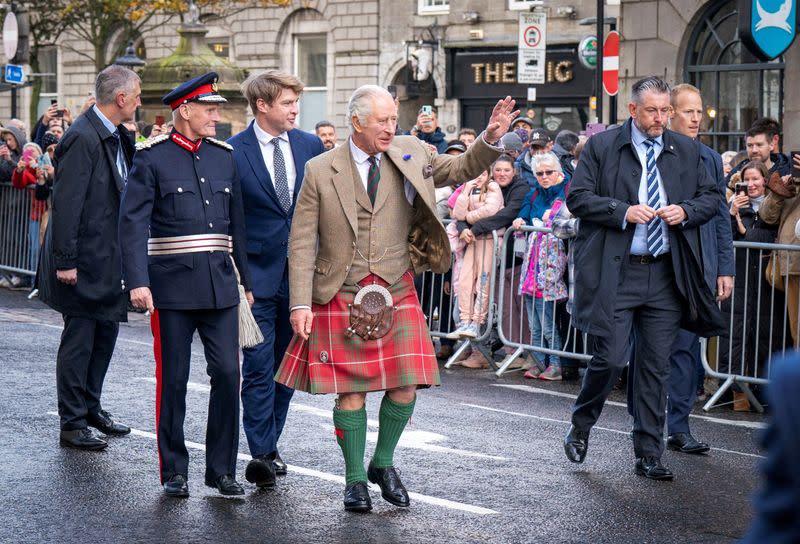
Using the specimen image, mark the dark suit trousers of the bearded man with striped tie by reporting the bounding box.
[572,258,681,457]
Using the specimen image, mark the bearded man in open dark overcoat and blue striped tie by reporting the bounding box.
[564,77,721,480]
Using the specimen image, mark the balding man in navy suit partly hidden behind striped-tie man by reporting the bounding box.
[628,84,735,454]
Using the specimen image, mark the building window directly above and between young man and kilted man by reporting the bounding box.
[294,34,328,132]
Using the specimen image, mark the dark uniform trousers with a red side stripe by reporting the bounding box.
[151,306,239,482]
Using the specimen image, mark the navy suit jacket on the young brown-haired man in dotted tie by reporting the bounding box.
[228,121,325,298]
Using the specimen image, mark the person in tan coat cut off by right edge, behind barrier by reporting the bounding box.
[758,155,800,347]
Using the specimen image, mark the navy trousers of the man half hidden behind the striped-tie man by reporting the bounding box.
[628,329,702,434]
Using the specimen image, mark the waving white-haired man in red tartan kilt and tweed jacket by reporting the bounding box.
[275,85,519,512]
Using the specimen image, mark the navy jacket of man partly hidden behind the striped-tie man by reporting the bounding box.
[700,144,736,292]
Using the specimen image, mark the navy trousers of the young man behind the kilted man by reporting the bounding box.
[242,278,294,457]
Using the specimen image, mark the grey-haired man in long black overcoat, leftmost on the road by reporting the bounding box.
[37,65,141,450]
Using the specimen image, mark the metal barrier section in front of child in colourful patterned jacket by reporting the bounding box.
[495,226,592,376]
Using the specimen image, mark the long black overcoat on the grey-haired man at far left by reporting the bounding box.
[37,109,134,321]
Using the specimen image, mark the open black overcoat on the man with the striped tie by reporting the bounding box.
[567,119,723,336]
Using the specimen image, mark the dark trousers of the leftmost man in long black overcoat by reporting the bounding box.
[56,315,119,431]
